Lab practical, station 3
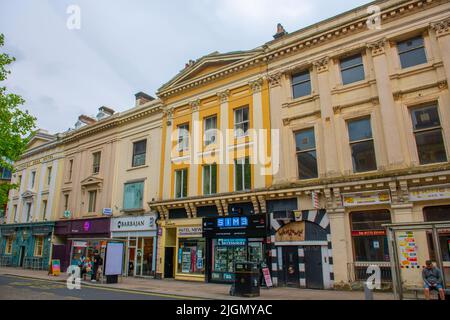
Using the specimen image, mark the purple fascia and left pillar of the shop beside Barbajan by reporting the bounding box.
[52,218,111,272]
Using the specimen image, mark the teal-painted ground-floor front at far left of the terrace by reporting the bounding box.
[0,223,54,270]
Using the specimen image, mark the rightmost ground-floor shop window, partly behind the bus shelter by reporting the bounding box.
[423,206,450,262]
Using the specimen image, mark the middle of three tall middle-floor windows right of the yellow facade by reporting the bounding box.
[348,118,377,172]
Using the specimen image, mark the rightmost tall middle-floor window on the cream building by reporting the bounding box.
[411,105,447,164]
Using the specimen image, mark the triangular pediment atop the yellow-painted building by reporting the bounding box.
[158,50,259,92]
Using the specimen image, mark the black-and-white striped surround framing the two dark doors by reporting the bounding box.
[270,209,334,289]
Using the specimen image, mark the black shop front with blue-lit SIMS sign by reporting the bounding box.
[203,214,267,283]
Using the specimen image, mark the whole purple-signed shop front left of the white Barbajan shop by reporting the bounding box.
[52,217,111,272]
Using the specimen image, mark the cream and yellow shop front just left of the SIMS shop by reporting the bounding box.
[157,218,205,281]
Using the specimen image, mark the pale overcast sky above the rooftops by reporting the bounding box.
[0,0,370,133]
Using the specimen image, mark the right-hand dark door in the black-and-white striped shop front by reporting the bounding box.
[303,246,323,289]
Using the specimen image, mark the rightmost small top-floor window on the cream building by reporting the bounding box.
[397,36,427,69]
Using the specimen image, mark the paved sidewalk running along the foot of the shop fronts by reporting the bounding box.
[0,267,393,300]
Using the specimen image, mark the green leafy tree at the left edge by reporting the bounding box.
[0,33,36,207]
